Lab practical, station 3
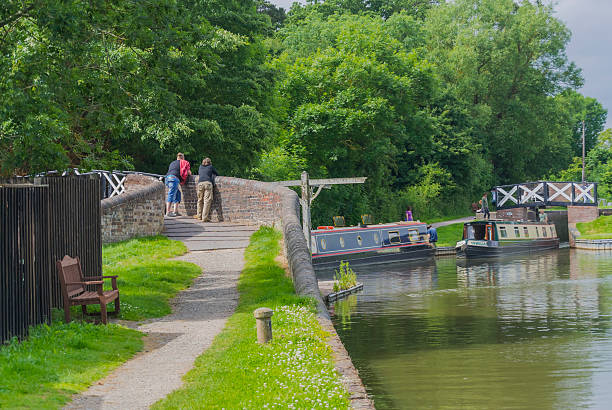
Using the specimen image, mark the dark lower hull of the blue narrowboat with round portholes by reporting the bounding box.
[312,245,435,268]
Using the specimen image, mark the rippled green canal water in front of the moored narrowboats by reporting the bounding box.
[318,249,612,409]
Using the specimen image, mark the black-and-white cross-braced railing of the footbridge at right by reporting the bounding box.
[493,181,597,209]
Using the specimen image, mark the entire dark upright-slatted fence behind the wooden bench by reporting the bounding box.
[0,174,102,342]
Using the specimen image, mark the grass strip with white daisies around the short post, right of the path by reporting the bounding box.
[154,227,349,409]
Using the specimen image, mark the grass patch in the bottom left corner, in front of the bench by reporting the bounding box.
[0,322,142,409]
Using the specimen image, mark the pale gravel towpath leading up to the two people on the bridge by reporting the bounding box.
[66,217,256,409]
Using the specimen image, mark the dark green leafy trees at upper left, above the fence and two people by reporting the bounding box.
[0,0,274,174]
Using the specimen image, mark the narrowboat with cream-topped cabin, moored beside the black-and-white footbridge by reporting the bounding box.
[456,220,559,258]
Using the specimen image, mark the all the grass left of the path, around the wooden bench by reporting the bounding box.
[0,236,201,408]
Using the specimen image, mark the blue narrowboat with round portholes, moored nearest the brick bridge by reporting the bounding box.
[311,221,434,268]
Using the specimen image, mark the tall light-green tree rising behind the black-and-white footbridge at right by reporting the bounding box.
[425,0,581,182]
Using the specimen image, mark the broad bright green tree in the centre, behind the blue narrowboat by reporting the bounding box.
[266,12,480,222]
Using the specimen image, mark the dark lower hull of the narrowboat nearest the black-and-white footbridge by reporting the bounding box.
[457,238,559,258]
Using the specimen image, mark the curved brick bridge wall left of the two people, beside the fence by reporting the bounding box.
[102,175,165,243]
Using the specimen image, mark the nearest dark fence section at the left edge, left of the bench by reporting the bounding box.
[0,184,52,342]
